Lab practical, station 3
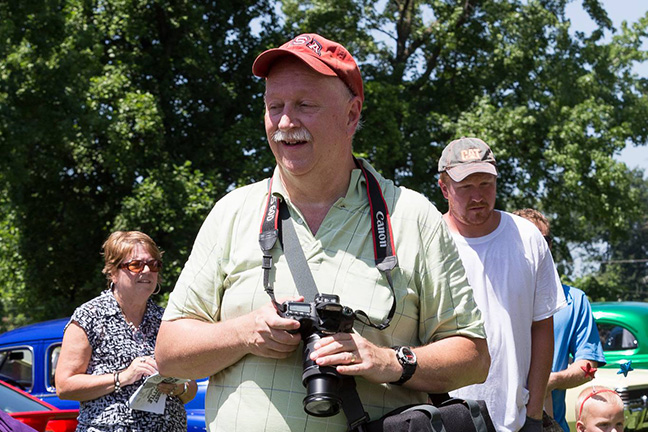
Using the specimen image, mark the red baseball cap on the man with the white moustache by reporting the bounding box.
[252,33,364,101]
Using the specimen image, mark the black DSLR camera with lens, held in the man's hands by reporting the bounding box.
[279,294,355,417]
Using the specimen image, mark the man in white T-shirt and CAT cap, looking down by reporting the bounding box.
[439,137,565,432]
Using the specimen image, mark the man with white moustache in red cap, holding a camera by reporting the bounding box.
[156,34,489,432]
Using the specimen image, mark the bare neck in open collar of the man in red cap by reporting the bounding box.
[279,159,355,234]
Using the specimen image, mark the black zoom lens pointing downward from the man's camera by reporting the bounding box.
[302,333,342,417]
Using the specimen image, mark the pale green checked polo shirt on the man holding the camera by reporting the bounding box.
[164,161,485,432]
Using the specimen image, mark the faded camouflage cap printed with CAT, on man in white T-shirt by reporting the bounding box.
[439,137,497,182]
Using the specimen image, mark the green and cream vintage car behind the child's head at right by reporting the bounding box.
[565,302,648,431]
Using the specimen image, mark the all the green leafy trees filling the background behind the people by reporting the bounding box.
[0,0,648,323]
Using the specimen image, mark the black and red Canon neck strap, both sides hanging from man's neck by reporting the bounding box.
[259,158,398,330]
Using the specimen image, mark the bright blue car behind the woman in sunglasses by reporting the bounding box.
[0,318,207,432]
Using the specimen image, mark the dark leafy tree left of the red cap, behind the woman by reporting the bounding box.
[0,0,272,320]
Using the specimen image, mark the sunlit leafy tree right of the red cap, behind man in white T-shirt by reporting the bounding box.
[282,0,648,280]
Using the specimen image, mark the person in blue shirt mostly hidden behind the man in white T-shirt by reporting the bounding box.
[514,209,605,432]
